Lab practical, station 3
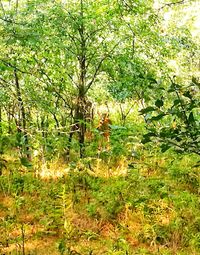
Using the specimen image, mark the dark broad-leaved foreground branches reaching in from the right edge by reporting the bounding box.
[141,78,200,155]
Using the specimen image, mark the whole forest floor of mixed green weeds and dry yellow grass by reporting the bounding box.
[0,152,200,255]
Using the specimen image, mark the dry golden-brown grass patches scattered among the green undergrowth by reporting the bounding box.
[0,152,197,255]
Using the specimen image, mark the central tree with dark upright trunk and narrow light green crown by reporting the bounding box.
[28,0,121,157]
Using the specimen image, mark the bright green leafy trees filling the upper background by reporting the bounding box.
[0,0,199,159]
